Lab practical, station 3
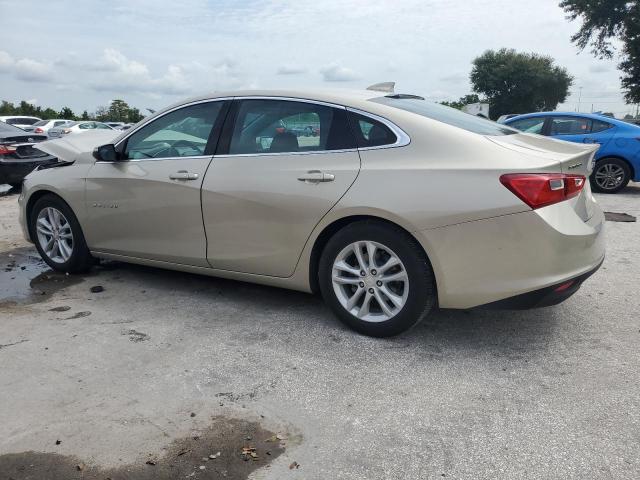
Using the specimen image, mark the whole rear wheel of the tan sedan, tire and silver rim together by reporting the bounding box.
[318,220,437,337]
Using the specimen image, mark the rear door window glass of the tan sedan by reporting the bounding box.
[229,100,355,155]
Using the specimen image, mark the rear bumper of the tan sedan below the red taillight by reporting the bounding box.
[418,202,605,309]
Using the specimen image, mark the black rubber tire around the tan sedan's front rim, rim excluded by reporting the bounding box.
[29,195,93,273]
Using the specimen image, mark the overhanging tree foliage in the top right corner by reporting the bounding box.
[560,0,640,103]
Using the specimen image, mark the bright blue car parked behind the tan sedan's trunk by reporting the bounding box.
[504,112,640,193]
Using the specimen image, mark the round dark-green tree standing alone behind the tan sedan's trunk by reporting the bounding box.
[471,48,573,118]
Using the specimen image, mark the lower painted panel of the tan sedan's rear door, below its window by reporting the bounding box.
[202,151,360,277]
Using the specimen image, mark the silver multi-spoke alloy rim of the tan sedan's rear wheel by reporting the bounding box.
[331,241,409,322]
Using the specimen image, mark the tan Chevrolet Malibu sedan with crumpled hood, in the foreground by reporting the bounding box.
[19,90,604,336]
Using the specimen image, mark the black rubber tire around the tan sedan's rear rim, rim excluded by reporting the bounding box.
[318,221,437,337]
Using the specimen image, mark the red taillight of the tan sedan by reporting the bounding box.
[500,173,586,210]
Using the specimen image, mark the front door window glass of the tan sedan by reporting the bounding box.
[124,101,223,160]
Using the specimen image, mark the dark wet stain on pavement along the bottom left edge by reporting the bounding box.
[0,417,286,480]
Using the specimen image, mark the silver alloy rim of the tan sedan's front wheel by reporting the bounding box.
[36,207,73,263]
